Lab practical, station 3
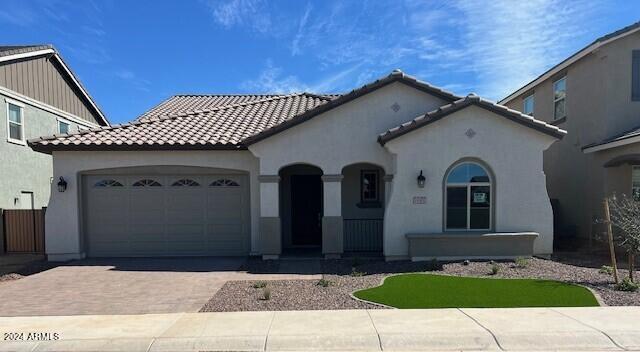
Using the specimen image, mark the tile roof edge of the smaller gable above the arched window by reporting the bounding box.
[378,94,567,145]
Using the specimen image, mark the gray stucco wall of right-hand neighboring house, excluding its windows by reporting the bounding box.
[504,31,640,243]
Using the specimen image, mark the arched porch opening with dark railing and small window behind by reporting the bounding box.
[342,163,385,253]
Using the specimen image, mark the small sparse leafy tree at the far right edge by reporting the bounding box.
[608,194,640,281]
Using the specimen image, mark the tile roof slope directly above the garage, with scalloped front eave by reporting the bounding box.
[29,93,330,152]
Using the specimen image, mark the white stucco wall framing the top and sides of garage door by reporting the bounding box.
[45,151,260,260]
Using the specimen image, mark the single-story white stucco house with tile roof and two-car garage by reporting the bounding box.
[29,70,565,260]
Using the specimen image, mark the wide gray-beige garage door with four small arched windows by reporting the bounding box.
[83,175,249,257]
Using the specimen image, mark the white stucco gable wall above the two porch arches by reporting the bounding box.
[249,82,446,175]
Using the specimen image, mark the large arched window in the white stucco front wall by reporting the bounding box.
[445,162,492,230]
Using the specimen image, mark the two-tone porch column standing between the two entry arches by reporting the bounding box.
[322,175,344,259]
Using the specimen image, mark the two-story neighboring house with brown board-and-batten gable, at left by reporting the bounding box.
[0,45,109,253]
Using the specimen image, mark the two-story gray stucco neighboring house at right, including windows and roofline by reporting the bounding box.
[500,22,640,245]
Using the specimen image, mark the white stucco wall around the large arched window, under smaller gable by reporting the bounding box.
[384,107,555,257]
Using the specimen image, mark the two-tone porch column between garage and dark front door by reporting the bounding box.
[258,175,282,259]
